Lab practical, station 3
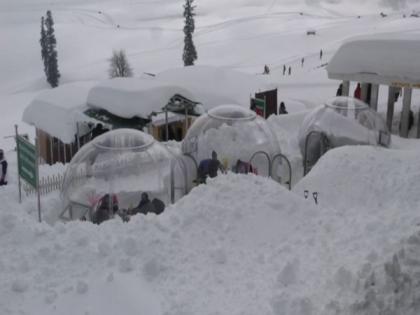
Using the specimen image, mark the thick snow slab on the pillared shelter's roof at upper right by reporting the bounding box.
[327,36,420,87]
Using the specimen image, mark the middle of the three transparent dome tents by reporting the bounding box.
[182,105,291,188]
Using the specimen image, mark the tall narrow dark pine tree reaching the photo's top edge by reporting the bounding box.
[182,0,197,66]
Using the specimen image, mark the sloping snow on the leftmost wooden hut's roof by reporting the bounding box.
[22,81,96,143]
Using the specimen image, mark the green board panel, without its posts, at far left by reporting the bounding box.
[16,136,38,188]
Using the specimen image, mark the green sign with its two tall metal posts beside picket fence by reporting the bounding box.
[15,126,41,222]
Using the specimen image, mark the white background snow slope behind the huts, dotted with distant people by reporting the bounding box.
[0,0,419,148]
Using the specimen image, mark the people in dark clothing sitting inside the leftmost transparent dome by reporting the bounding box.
[92,192,165,224]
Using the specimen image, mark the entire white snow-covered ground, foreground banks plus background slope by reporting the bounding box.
[0,0,420,315]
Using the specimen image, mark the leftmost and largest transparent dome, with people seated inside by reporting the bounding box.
[61,129,186,223]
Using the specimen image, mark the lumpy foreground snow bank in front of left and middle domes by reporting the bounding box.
[0,170,416,315]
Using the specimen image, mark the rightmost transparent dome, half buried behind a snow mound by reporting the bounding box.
[299,96,391,174]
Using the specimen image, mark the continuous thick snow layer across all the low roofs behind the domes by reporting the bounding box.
[23,66,275,143]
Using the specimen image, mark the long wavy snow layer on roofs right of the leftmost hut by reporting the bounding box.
[87,66,275,118]
